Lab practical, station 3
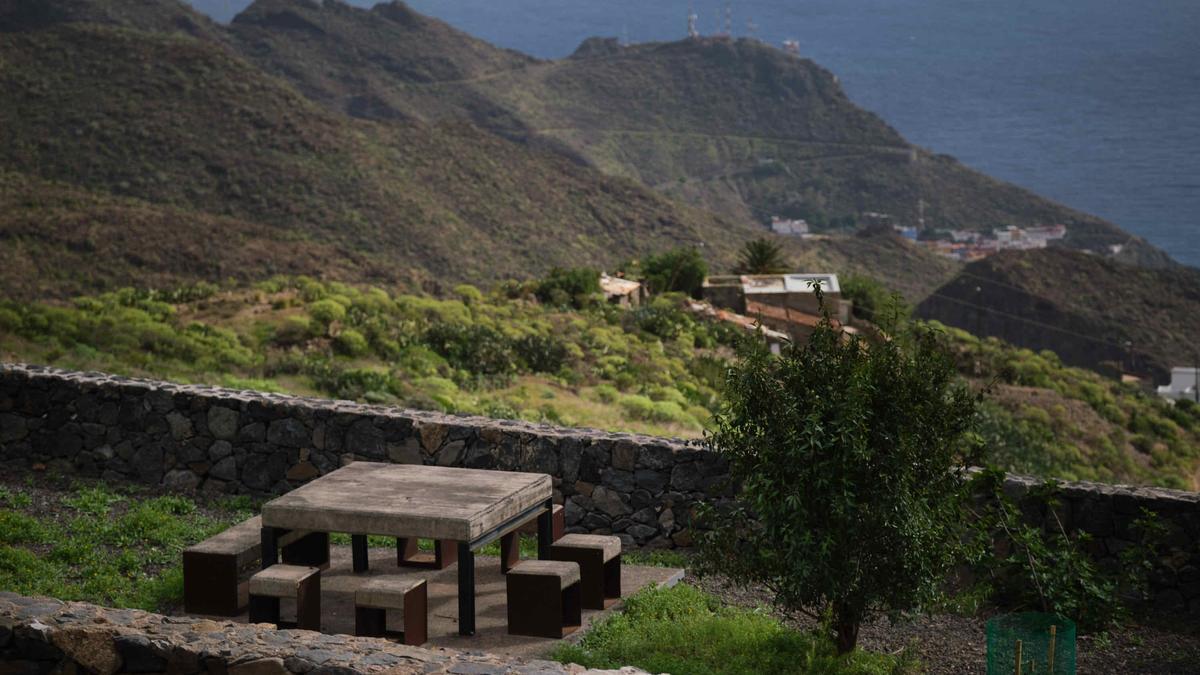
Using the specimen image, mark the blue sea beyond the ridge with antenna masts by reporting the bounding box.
[184,0,1200,267]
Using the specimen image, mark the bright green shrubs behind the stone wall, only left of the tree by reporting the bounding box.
[0,269,739,434]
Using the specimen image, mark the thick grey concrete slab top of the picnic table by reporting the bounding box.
[263,461,553,542]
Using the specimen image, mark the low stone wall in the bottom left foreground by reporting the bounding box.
[0,593,643,675]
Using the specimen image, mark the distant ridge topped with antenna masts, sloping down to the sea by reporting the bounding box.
[218,0,1168,265]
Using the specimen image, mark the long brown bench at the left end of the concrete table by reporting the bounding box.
[184,515,329,616]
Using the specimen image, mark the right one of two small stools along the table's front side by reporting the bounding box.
[354,577,430,646]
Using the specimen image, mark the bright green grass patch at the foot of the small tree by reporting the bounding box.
[552,584,916,675]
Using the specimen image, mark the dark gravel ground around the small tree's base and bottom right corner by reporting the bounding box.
[684,574,1200,675]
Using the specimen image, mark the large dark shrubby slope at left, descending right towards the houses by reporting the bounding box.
[0,16,749,292]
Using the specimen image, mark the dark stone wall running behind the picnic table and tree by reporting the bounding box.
[0,364,1200,614]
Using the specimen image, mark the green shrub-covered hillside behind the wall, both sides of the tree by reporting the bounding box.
[0,277,1200,490]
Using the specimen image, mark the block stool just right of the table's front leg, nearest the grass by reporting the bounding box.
[504,560,583,639]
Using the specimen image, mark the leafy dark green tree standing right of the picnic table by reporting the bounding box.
[701,288,978,653]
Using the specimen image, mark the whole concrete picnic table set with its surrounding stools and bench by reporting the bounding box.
[184,462,620,645]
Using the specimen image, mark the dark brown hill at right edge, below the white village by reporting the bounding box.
[917,249,1200,382]
